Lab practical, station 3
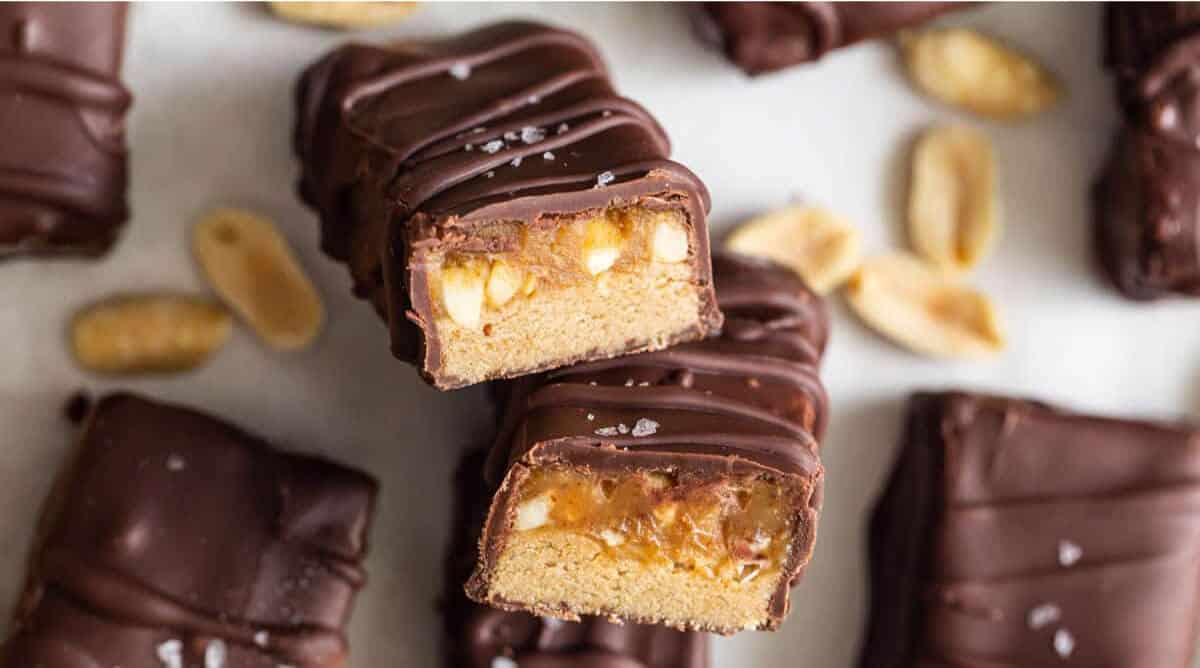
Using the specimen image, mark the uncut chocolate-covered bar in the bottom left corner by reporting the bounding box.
[0,395,377,668]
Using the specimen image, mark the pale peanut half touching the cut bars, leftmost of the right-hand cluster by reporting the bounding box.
[725,206,859,294]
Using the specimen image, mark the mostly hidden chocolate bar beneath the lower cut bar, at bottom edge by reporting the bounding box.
[442,450,708,668]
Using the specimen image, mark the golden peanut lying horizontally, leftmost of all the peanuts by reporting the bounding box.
[71,295,232,374]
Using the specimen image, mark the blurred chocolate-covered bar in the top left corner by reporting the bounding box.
[0,2,131,259]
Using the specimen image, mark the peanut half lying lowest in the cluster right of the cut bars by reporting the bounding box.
[846,253,1004,357]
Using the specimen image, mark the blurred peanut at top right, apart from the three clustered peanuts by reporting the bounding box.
[900,28,1061,120]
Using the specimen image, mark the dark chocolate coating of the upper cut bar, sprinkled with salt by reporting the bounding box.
[295,23,720,389]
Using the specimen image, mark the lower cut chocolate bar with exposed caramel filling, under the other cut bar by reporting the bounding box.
[467,257,829,633]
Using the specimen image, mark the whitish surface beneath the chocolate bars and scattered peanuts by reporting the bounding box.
[0,4,1200,668]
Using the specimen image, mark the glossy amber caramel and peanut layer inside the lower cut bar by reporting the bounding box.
[512,467,792,582]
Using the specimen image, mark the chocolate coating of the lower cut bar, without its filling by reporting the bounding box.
[468,254,829,624]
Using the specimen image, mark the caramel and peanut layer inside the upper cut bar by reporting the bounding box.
[430,207,689,330]
